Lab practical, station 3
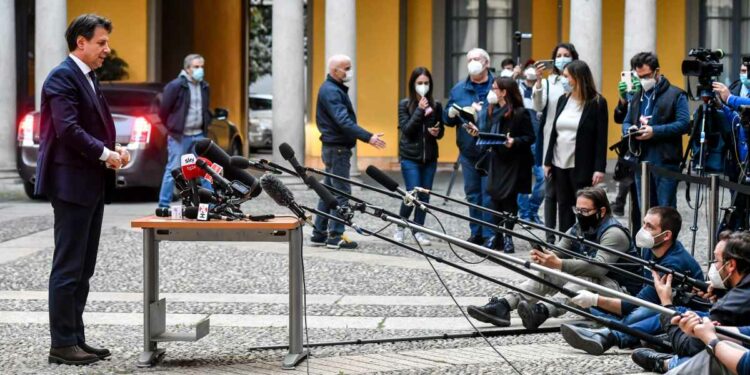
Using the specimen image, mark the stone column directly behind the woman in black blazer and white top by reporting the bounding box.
[570,0,602,90]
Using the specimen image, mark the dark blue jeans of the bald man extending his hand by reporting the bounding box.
[313,145,352,239]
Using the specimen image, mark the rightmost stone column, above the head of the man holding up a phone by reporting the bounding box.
[622,0,656,70]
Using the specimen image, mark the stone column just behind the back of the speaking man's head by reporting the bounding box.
[34,0,68,110]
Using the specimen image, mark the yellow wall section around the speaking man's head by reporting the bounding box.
[68,0,148,82]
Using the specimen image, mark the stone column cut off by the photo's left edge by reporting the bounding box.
[0,0,18,171]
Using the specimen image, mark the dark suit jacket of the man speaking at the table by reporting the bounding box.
[35,57,115,206]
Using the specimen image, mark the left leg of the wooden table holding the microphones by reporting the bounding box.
[137,229,164,367]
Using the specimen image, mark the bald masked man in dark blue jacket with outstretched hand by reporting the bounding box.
[310,55,385,249]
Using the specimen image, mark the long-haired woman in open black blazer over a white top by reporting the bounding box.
[544,60,609,235]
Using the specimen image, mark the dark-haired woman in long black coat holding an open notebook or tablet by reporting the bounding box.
[470,77,536,253]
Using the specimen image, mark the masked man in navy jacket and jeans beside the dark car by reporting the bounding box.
[159,54,211,207]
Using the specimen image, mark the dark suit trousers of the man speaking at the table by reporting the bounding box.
[49,193,104,348]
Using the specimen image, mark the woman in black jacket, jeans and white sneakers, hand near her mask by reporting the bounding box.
[393,67,445,246]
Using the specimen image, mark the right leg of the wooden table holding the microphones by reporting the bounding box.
[282,228,308,369]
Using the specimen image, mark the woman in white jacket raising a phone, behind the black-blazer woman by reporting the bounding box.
[531,43,578,243]
